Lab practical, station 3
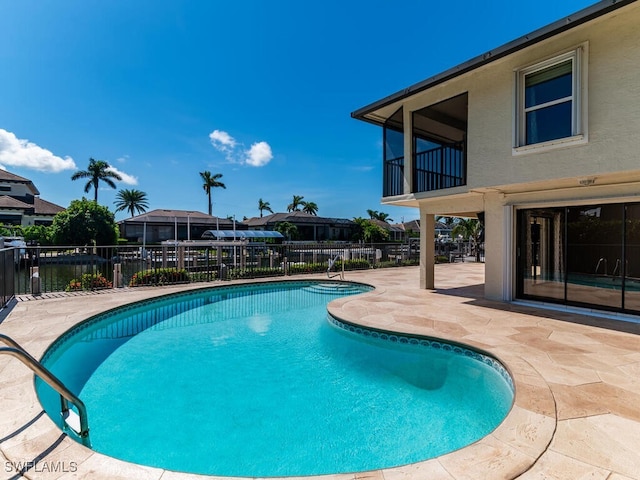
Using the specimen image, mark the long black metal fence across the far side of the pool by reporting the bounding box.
[8,242,420,295]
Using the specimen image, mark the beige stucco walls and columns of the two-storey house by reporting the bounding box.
[358,2,640,300]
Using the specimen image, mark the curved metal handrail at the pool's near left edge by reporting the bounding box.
[0,334,91,447]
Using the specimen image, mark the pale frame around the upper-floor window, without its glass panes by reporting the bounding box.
[513,43,588,155]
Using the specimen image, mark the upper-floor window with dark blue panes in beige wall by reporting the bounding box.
[515,49,584,148]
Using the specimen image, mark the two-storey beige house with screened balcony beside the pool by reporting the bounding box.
[352,0,640,314]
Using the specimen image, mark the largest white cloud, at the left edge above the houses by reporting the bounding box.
[0,128,76,173]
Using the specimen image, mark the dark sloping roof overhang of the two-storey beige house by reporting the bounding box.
[351,0,637,125]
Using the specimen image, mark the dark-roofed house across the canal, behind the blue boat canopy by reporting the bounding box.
[245,212,356,242]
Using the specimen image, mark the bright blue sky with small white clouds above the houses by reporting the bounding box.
[0,0,594,222]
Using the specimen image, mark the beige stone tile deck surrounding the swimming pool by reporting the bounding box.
[0,263,640,480]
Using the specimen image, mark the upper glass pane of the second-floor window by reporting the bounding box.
[525,60,573,108]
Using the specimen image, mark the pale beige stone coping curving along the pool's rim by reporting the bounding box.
[0,277,557,480]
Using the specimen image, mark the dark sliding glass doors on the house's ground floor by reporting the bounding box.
[516,203,640,313]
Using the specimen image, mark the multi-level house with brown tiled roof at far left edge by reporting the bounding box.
[0,170,65,227]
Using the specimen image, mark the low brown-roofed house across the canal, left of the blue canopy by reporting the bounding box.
[118,209,247,243]
